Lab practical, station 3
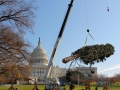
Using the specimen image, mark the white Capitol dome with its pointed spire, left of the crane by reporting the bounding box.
[32,38,48,65]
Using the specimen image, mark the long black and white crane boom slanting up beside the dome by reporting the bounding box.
[44,0,74,79]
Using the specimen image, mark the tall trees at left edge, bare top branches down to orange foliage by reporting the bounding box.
[0,0,35,83]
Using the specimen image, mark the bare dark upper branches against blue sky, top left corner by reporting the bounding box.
[0,0,35,31]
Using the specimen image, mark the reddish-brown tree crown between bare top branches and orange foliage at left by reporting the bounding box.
[0,26,30,63]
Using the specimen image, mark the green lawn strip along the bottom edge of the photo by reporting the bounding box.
[0,85,120,90]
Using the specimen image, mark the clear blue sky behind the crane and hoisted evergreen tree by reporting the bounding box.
[25,0,120,76]
